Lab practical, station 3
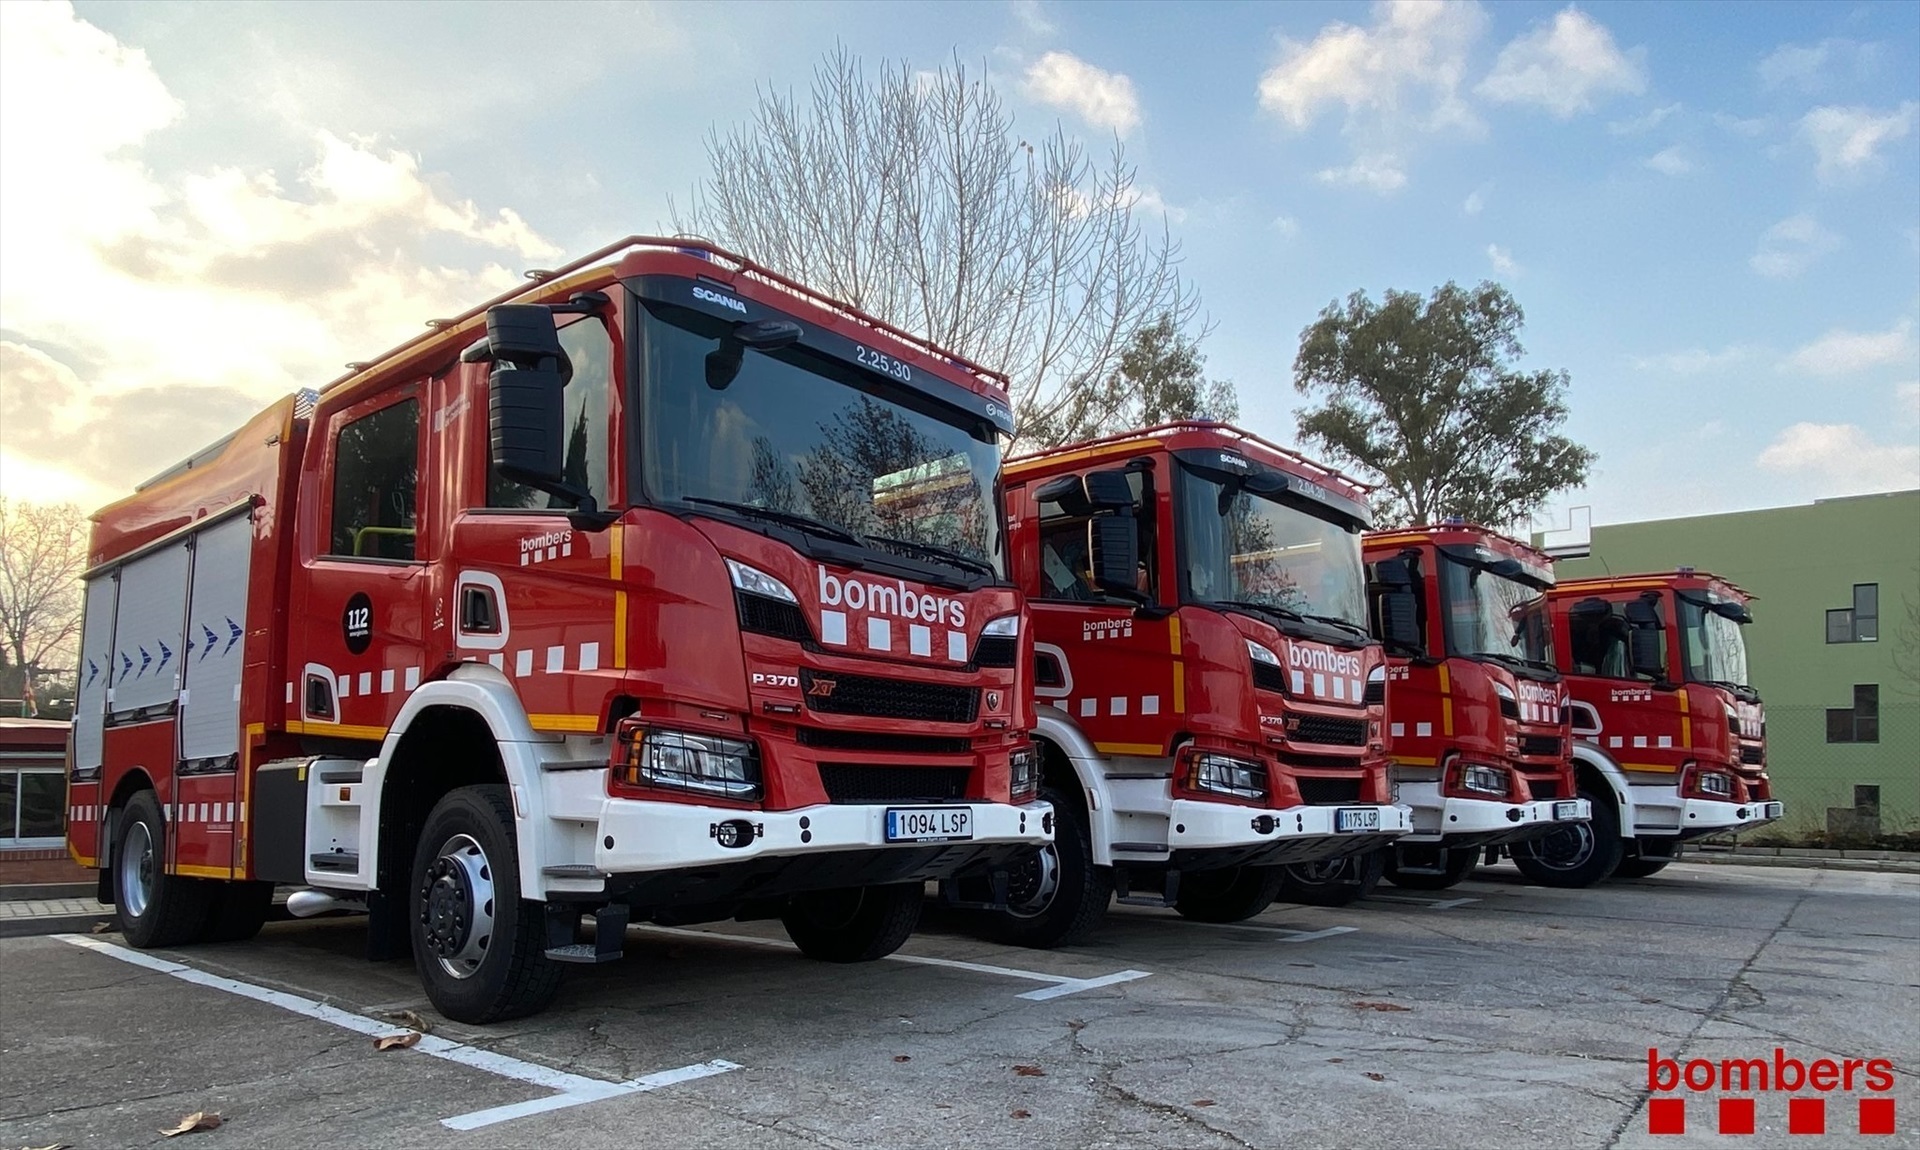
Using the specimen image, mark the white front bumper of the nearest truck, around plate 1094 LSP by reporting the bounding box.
[593,799,1054,874]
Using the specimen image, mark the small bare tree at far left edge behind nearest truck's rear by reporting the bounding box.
[0,499,86,714]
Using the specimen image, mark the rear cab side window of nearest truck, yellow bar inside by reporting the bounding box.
[328,399,420,561]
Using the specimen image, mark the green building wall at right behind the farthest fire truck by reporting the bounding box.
[1555,491,1920,837]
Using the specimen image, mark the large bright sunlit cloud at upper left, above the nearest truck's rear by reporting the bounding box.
[0,4,557,490]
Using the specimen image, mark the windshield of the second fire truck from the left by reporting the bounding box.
[1181,468,1367,635]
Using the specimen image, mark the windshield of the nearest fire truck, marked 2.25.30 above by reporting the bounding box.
[636,305,1006,580]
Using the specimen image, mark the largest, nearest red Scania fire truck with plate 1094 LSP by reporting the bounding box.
[71,236,1052,1021]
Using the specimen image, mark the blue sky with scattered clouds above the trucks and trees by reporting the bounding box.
[0,0,1920,528]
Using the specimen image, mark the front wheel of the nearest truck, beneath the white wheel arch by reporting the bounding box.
[407,783,563,1023]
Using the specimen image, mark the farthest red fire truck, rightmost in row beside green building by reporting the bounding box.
[1515,568,1782,887]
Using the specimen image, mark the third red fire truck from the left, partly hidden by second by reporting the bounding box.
[1365,520,1592,891]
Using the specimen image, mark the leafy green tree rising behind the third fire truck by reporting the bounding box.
[1294,282,1596,528]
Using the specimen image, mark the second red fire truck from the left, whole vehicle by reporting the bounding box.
[948,422,1409,946]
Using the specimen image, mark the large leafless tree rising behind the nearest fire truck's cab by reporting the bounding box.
[672,48,1194,451]
